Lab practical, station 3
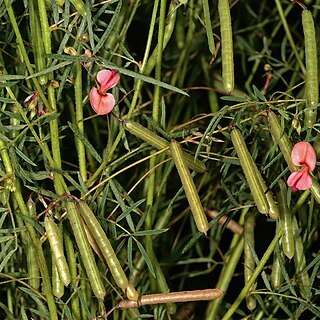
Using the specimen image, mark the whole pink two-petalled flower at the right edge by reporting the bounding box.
[287,142,317,192]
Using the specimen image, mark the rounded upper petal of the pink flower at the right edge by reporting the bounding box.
[291,141,317,171]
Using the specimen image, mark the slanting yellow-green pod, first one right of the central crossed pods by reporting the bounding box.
[231,129,269,214]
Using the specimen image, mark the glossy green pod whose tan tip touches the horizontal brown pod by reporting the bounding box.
[76,201,138,300]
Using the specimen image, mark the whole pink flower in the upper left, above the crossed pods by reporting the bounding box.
[89,70,120,115]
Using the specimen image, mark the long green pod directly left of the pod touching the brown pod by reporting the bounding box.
[66,201,106,300]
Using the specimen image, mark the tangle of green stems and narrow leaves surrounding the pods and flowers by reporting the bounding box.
[0,0,320,319]
